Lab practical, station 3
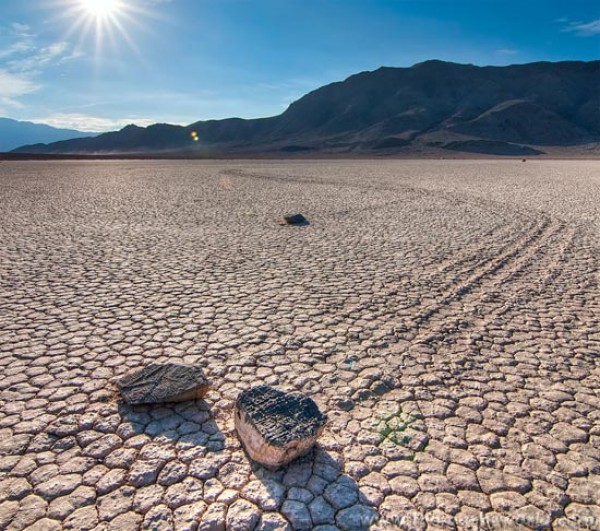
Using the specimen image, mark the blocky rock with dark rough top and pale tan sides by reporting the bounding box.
[235,385,327,467]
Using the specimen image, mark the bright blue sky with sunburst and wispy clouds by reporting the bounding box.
[0,0,600,131]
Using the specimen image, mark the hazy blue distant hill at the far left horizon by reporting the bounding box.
[0,118,97,152]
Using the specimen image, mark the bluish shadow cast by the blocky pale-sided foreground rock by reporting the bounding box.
[252,445,379,531]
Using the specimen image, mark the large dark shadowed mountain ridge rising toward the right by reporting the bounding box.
[10,61,600,154]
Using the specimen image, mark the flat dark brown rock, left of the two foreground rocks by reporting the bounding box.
[116,363,209,404]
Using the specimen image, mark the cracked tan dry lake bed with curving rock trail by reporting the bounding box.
[0,160,600,531]
